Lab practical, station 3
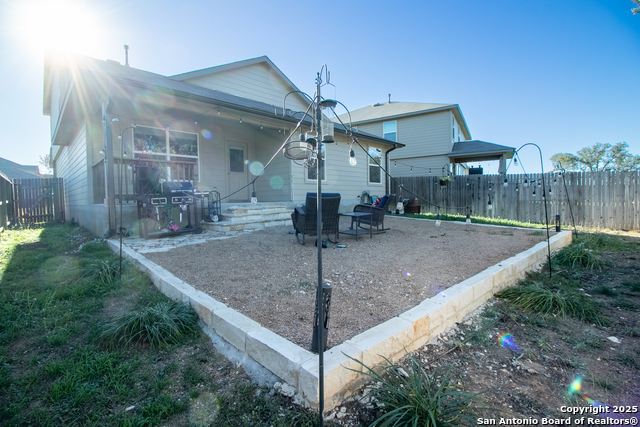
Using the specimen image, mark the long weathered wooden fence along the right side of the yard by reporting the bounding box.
[391,171,640,230]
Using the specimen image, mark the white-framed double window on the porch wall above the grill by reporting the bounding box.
[133,126,198,180]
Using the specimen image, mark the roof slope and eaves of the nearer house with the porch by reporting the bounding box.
[43,55,404,146]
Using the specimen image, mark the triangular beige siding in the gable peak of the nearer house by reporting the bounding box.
[185,63,308,111]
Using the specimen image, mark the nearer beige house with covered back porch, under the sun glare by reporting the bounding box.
[43,55,402,235]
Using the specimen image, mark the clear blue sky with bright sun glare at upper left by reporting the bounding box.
[0,0,640,173]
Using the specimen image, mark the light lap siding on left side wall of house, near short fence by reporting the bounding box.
[55,125,89,212]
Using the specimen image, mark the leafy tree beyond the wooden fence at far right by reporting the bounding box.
[551,142,640,172]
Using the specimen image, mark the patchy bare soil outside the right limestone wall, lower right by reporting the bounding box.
[325,232,640,426]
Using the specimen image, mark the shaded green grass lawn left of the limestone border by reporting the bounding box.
[0,225,317,426]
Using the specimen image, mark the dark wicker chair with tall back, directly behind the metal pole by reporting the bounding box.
[291,193,340,245]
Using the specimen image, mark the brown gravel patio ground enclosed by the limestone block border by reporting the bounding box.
[145,217,546,349]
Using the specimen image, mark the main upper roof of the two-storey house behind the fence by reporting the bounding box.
[332,102,471,139]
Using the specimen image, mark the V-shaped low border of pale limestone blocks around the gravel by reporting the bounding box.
[108,231,572,410]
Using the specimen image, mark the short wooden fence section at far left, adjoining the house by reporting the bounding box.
[9,178,64,225]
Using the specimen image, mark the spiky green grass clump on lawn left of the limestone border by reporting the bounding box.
[99,301,198,347]
